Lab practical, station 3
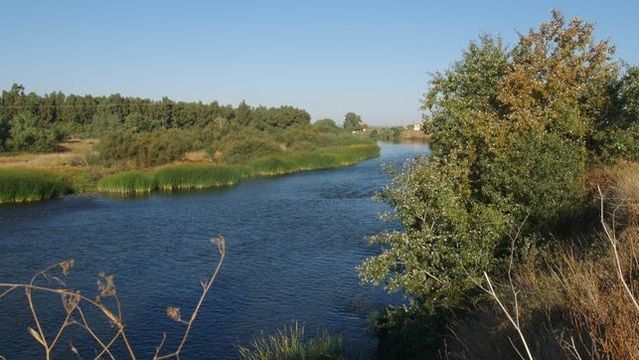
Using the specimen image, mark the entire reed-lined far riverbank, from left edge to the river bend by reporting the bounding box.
[0,141,379,203]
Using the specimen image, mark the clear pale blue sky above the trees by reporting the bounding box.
[0,0,639,125]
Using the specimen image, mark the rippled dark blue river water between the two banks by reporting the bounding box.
[0,144,428,359]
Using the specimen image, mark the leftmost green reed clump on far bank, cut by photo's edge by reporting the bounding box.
[0,169,71,203]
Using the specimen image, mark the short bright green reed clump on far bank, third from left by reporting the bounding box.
[153,164,242,190]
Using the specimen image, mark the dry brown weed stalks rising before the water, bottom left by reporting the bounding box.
[0,236,226,360]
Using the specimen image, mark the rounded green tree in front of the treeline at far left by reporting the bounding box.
[7,112,58,152]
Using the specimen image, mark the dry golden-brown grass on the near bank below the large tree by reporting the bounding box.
[446,163,639,359]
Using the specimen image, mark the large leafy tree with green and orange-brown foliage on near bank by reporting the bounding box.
[360,12,617,307]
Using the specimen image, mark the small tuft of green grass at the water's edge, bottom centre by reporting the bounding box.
[238,322,346,360]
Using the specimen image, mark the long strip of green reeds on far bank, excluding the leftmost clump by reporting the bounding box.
[97,142,379,195]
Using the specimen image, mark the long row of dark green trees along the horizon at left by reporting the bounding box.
[0,84,311,151]
